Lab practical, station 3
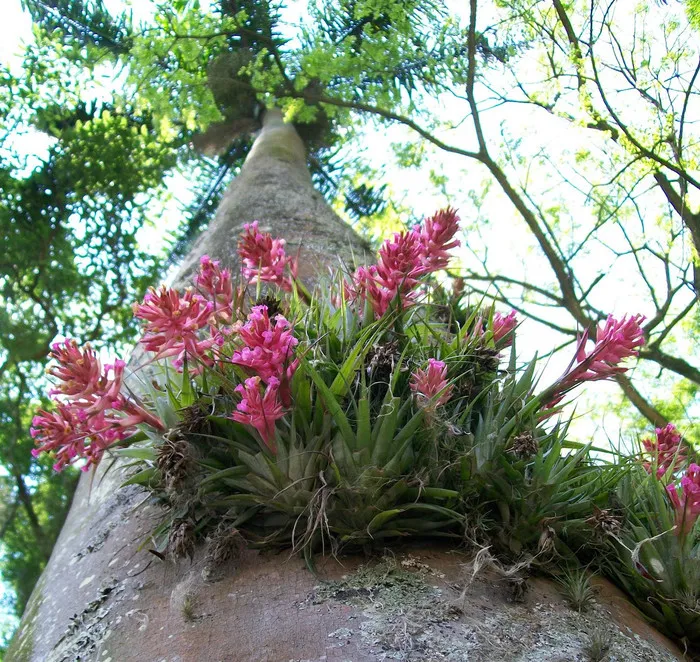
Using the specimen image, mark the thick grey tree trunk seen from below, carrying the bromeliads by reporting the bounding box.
[6,112,681,662]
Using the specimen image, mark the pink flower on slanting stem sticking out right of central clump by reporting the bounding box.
[544,315,645,409]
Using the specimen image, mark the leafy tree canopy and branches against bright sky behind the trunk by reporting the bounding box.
[0,0,700,652]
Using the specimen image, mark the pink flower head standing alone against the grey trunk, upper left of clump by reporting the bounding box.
[238,221,297,292]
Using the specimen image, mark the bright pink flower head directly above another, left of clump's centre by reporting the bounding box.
[231,306,299,384]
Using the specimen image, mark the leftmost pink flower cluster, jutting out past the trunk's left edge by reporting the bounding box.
[30,339,163,471]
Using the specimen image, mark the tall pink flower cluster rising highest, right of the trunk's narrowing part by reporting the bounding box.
[344,208,459,317]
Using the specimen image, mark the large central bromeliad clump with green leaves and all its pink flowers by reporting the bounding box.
[32,209,660,596]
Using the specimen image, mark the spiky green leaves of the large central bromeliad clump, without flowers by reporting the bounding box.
[118,272,616,563]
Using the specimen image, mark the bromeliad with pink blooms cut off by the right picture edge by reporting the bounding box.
[599,424,700,659]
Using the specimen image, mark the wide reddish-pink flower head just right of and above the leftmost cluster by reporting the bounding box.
[134,285,215,358]
